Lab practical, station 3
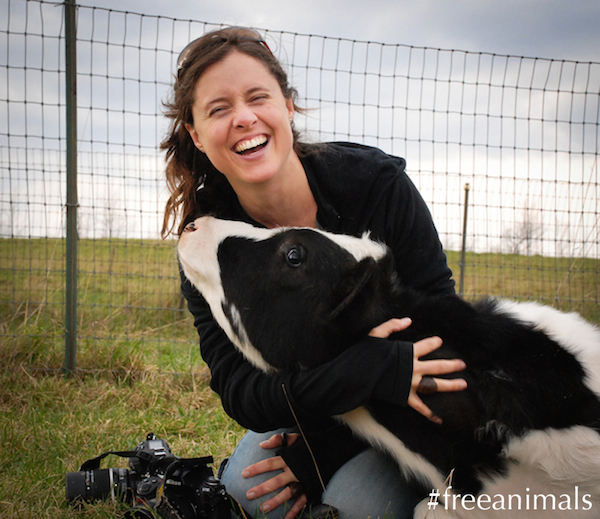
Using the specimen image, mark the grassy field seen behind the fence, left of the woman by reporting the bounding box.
[0,239,201,372]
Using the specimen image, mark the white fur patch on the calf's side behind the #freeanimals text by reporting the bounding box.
[414,427,600,519]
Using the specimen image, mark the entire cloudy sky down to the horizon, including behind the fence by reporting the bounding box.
[0,0,600,257]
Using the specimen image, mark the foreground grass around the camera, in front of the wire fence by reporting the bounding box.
[0,347,243,519]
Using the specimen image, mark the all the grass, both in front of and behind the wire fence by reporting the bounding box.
[0,239,600,519]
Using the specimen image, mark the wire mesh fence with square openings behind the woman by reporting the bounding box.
[0,0,600,372]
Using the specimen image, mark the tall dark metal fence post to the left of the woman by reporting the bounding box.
[64,0,78,376]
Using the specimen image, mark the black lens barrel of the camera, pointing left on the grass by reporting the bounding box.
[65,468,129,501]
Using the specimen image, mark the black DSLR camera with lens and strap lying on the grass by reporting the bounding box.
[65,433,233,519]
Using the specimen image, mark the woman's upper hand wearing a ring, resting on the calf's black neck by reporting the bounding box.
[369,317,467,424]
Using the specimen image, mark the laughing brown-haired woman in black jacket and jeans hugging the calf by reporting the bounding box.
[162,27,466,519]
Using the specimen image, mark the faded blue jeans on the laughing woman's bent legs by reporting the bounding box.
[221,429,426,519]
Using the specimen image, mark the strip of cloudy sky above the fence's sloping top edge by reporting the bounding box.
[79,0,600,62]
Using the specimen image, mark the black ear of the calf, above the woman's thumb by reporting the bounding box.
[326,258,381,335]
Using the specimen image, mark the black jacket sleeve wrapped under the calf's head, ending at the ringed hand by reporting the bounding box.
[182,274,412,432]
